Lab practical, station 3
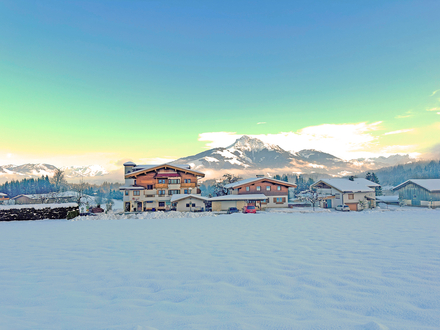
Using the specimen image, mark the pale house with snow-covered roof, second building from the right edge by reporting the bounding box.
[310,178,380,211]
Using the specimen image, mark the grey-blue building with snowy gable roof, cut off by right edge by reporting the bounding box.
[393,179,440,208]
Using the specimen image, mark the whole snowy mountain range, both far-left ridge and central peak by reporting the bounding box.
[0,135,414,181]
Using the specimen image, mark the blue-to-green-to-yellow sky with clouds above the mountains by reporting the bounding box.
[0,0,440,170]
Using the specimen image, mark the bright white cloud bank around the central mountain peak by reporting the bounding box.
[199,122,381,159]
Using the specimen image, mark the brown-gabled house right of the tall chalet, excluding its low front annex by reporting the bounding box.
[223,176,296,209]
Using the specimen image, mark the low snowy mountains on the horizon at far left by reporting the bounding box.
[0,163,108,179]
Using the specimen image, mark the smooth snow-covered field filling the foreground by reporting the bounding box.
[0,209,440,330]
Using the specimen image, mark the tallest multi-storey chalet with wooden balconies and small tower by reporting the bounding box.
[119,162,205,212]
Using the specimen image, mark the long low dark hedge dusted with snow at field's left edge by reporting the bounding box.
[0,206,78,221]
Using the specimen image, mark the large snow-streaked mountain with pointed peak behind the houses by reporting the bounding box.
[174,135,411,176]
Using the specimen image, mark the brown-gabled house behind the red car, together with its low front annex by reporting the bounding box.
[219,175,296,210]
